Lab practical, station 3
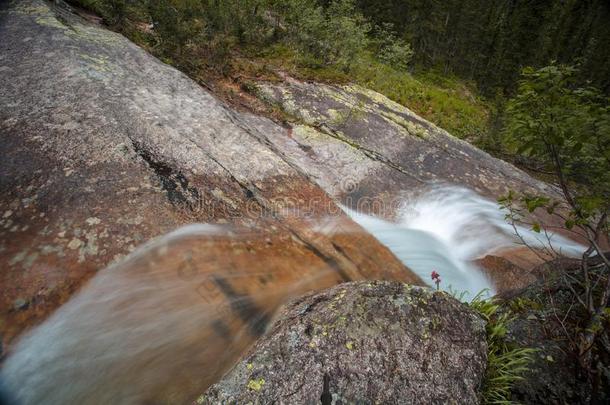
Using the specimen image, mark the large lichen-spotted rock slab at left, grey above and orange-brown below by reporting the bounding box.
[0,0,419,348]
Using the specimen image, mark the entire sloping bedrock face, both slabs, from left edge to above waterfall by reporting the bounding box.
[0,0,568,370]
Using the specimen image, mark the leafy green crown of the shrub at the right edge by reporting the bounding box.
[505,65,610,218]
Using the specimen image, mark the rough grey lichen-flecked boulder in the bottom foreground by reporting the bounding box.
[202,282,487,404]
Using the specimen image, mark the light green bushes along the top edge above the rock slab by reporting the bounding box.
[74,0,376,72]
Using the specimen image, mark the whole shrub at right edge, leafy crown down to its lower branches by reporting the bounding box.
[500,63,610,381]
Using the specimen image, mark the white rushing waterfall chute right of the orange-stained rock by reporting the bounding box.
[344,185,584,298]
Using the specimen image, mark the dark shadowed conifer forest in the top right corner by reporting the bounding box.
[358,0,610,97]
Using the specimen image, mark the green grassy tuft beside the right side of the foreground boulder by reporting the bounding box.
[470,292,535,404]
